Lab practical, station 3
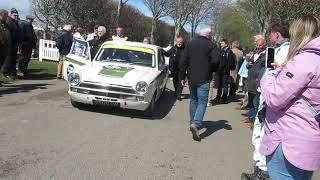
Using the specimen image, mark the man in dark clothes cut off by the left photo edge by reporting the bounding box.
[0,9,11,86]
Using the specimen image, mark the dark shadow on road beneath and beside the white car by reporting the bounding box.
[81,89,176,120]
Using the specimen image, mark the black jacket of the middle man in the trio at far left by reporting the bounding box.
[6,17,22,49]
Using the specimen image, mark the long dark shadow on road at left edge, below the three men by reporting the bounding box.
[0,83,52,97]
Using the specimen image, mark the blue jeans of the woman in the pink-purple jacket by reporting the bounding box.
[266,144,313,180]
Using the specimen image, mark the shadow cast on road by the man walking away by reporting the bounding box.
[200,120,232,139]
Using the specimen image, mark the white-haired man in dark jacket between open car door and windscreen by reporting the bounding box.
[89,26,108,59]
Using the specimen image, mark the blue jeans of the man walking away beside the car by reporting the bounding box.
[189,83,210,128]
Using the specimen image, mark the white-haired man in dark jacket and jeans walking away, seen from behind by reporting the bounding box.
[180,28,218,141]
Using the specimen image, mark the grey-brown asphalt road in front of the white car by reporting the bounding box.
[0,80,320,180]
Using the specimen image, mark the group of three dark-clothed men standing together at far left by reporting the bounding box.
[0,8,37,86]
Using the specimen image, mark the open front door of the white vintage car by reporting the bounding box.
[63,39,91,80]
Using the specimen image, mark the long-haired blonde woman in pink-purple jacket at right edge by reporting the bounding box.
[260,16,320,180]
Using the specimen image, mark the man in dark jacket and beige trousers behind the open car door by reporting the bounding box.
[57,25,73,79]
